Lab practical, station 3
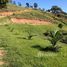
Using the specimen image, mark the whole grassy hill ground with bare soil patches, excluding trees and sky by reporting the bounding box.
[0,5,67,67]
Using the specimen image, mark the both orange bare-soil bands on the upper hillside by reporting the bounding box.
[0,10,52,25]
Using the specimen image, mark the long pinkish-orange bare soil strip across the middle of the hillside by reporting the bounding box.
[11,18,52,25]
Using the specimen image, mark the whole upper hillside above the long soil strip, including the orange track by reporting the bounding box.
[0,4,67,24]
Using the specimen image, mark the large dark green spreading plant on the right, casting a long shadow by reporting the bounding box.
[44,25,63,50]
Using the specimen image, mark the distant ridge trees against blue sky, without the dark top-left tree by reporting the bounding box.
[11,1,67,16]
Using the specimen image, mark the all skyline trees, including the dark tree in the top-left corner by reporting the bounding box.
[0,0,67,17]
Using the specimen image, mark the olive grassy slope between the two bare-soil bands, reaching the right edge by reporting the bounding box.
[12,8,67,24]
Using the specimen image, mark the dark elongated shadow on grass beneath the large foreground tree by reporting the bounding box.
[32,45,60,52]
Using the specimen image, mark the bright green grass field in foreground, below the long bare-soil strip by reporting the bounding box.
[0,24,67,67]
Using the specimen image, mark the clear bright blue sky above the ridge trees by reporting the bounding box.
[13,0,67,12]
